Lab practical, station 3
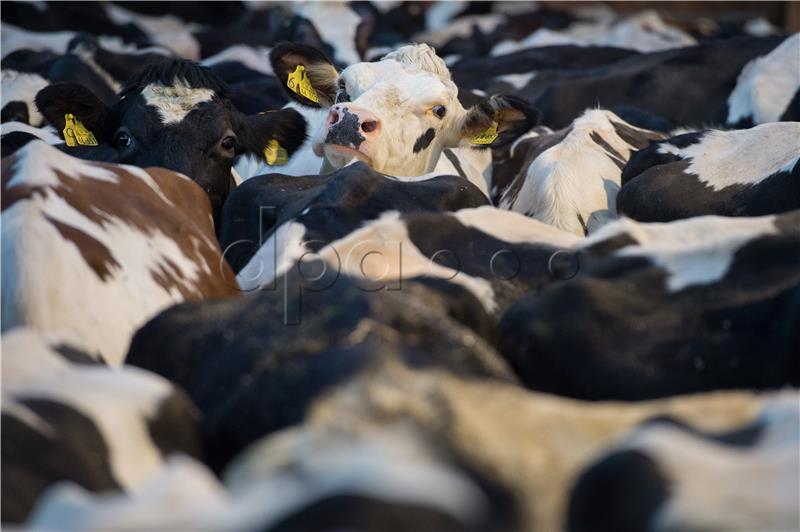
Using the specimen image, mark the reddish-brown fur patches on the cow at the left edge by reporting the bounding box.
[2,155,239,300]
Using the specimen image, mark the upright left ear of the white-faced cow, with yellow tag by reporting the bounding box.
[269,43,339,107]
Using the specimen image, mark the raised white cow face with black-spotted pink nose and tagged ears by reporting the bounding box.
[270,44,537,176]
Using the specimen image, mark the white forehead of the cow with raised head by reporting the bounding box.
[342,59,458,103]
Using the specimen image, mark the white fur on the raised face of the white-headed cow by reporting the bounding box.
[313,46,466,176]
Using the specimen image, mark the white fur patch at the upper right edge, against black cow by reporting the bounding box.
[727,33,800,124]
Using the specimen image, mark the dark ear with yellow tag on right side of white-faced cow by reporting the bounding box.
[461,94,539,148]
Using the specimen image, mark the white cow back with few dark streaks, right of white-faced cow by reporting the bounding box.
[495,110,665,235]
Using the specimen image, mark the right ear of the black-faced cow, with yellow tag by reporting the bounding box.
[236,108,306,165]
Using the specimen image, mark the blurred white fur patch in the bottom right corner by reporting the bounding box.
[622,392,800,530]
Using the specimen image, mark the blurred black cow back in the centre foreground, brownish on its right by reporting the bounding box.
[126,260,515,470]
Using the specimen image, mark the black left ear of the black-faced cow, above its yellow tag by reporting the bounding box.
[35,83,109,138]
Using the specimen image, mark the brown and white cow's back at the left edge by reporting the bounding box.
[2,141,237,365]
